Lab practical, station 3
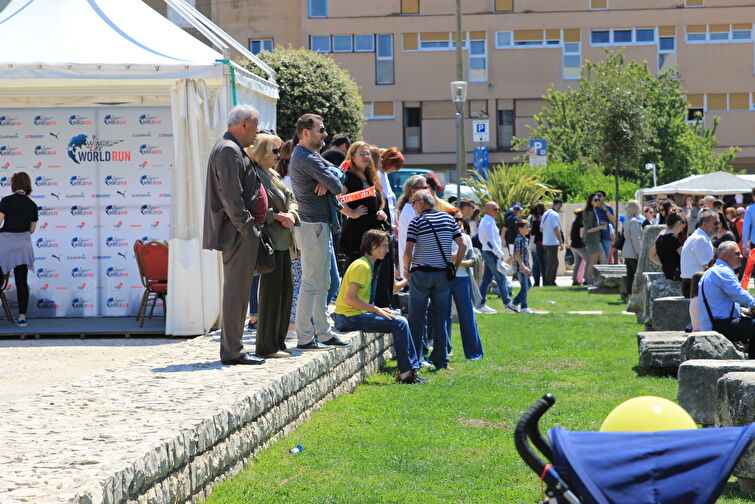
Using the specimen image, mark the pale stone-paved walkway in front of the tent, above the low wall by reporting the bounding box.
[0,334,350,504]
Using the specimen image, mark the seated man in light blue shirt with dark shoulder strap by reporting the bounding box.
[698,241,755,359]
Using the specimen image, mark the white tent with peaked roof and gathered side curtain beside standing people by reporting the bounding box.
[0,0,278,335]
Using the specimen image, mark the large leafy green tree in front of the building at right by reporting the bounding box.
[516,51,739,194]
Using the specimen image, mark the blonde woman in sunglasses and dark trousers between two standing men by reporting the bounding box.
[247,134,299,357]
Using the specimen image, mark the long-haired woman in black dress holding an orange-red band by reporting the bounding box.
[340,142,388,264]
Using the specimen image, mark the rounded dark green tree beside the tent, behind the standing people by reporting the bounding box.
[244,46,364,140]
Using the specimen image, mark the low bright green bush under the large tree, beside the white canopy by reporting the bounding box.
[542,161,640,203]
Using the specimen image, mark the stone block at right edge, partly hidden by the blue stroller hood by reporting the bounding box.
[715,370,755,482]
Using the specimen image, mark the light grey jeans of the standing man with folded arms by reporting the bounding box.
[295,222,333,345]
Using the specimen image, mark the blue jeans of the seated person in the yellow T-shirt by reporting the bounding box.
[333,313,419,373]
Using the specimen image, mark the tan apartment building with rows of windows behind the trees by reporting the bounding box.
[150,0,755,178]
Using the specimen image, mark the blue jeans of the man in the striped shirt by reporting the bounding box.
[409,271,452,369]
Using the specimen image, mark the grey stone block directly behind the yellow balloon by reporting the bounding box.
[677,359,755,425]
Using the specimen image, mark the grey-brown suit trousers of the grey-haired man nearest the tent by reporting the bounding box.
[220,232,260,360]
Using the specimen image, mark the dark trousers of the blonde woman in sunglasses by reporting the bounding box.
[257,250,294,355]
